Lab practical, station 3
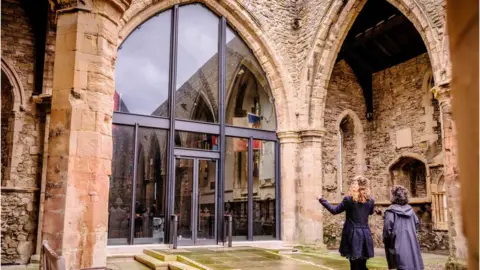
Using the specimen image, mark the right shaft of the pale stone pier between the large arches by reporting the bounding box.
[297,130,324,248]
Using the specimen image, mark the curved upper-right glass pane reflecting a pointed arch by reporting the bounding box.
[225,27,276,130]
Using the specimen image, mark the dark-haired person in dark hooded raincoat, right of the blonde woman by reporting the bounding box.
[383,186,423,270]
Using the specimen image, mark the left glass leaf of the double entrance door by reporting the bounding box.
[173,159,194,240]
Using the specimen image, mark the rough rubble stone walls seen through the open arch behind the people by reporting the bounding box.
[323,54,448,250]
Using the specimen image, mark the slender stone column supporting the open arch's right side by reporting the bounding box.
[433,84,467,259]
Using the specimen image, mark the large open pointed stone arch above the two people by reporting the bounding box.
[300,0,447,129]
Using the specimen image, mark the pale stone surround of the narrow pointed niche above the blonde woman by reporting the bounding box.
[335,109,365,192]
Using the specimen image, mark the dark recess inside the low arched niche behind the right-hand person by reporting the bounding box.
[389,155,429,198]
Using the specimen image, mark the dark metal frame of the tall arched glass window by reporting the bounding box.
[112,4,281,245]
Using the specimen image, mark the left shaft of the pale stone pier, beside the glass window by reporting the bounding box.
[278,131,300,244]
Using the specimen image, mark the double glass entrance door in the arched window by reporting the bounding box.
[173,157,218,246]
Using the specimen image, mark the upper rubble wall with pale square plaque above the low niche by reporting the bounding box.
[367,54,441,200]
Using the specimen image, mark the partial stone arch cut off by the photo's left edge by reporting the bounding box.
[1,56,25,186]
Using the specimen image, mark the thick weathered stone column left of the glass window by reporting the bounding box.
[43,0,130,269]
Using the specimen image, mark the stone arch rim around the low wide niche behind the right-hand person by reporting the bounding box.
[387,152,431,198]
